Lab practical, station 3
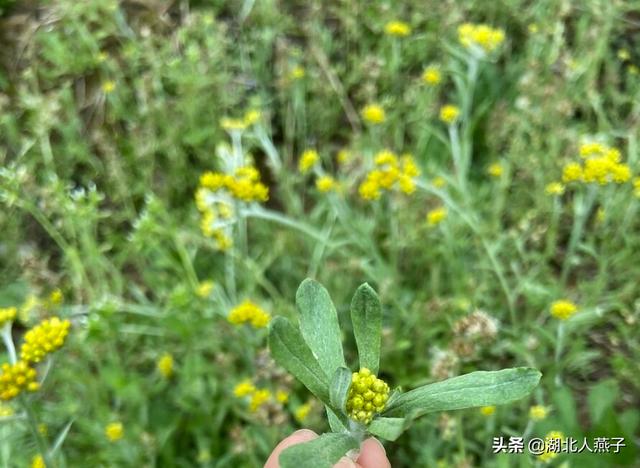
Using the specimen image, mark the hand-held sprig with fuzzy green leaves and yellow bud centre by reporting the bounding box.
[269,279,541,468]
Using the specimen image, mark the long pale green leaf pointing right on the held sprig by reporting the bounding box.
[383,367,542,417]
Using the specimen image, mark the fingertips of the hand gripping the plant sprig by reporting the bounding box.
[264,429,391,468]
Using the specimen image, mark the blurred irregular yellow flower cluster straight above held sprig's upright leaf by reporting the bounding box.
[358,150,420,200]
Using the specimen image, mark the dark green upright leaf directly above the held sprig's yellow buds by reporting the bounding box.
[351,283,382,375]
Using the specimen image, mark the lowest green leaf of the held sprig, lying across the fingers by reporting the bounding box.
[279,433,359,468]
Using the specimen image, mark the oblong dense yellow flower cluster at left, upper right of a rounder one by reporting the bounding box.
[20,317,71,364]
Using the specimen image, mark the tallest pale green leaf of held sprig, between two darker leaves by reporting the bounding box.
[296,278,346,376]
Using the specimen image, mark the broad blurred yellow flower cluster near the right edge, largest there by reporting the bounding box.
[562,143,631,185]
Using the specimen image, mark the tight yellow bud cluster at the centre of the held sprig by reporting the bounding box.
[347,367,389,424]
